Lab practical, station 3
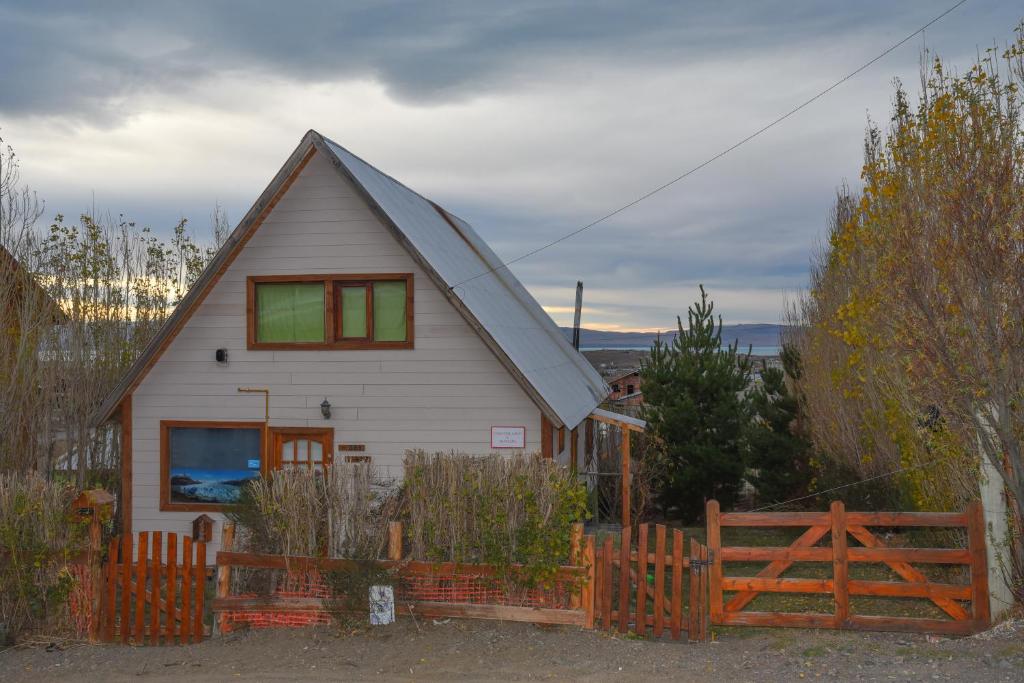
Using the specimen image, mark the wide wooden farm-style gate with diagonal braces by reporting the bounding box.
[707,501,990,635]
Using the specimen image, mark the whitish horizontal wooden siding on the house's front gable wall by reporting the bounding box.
[131,155,541,557]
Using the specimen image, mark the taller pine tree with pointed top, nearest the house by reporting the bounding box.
[640,285,751,520]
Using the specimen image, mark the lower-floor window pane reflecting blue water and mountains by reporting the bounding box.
[168,427,261,503]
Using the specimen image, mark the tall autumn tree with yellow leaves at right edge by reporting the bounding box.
[792,24,1024,593]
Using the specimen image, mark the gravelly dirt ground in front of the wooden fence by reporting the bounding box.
[0,618,1024,683]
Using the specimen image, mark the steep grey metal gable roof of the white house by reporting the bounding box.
[99,130,608,427]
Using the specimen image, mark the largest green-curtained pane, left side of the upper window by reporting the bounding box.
[256,283,324,342]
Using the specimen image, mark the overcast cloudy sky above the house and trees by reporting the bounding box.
[0,0,1024,329]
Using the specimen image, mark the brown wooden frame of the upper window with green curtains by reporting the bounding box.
[246,272,416,351]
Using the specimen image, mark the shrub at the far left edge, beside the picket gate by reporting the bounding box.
[0,473,87,641]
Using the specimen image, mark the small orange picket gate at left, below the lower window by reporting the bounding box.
[99,531,206,645]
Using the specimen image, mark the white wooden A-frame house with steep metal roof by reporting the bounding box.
[100,131,607,550]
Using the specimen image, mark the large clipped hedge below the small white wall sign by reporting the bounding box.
[403,451,587,585]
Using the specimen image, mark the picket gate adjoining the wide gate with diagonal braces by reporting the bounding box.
[594,524,708,641]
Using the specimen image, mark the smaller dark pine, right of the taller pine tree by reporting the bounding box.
[746,346,813,503]
